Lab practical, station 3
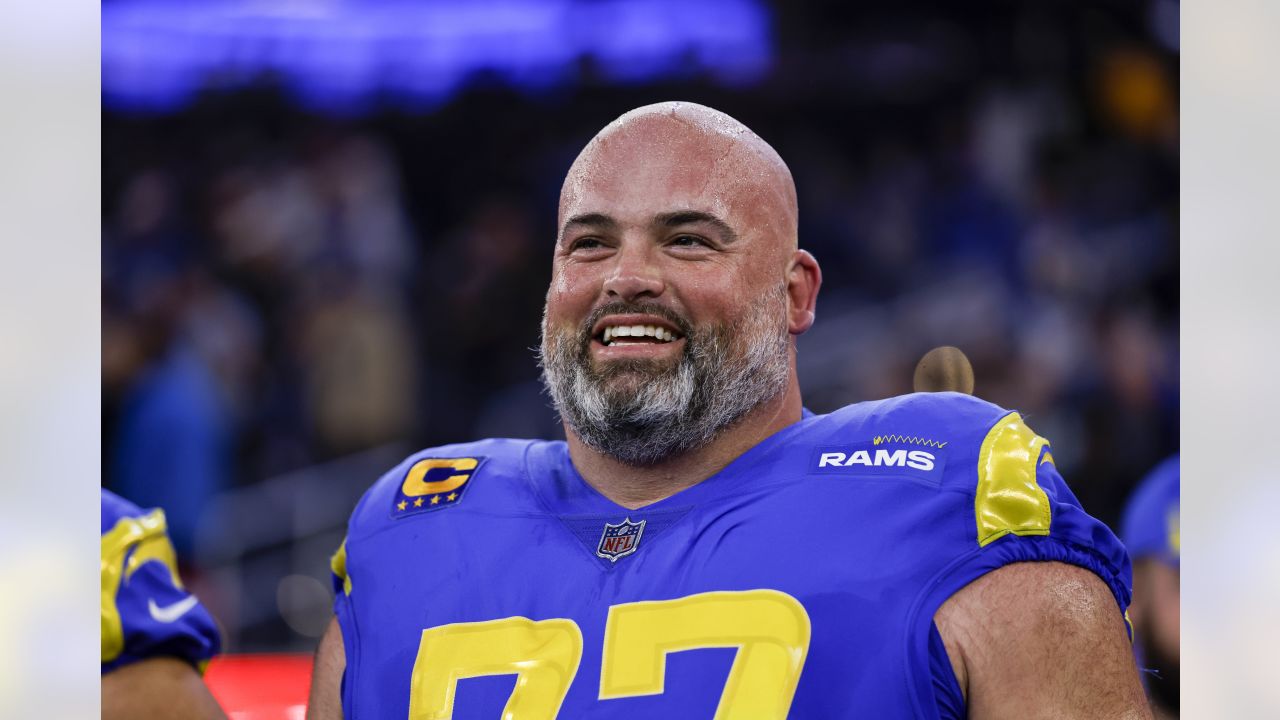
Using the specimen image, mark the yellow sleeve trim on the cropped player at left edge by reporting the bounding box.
[101,509,174,662]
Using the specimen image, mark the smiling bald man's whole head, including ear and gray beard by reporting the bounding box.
[543,102,822,466]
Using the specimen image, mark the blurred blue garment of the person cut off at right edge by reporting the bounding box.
[1120,455,1181,568]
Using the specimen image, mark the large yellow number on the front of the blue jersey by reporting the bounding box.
[408,589,809,720]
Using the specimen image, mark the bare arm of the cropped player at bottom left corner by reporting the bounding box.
[102,657,227,720]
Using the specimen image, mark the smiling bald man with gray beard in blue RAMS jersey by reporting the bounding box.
[308,102,1149,720]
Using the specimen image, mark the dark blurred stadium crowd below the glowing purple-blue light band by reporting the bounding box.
[102,1,1179,573]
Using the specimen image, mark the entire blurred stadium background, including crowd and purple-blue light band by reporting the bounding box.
[102,0,1179,652]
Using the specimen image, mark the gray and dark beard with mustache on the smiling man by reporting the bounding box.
[540,287,791,466]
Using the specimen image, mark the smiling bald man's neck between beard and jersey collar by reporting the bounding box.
[564,375,803,510]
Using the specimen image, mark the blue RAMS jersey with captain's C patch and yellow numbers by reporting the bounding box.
[333,393,1130,720]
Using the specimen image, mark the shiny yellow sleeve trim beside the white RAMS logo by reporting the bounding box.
[974,413,1053,546]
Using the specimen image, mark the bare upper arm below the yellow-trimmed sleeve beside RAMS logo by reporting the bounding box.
[934,562,1151,720]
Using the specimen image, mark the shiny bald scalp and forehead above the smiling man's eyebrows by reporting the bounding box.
[559,102,799,251]
